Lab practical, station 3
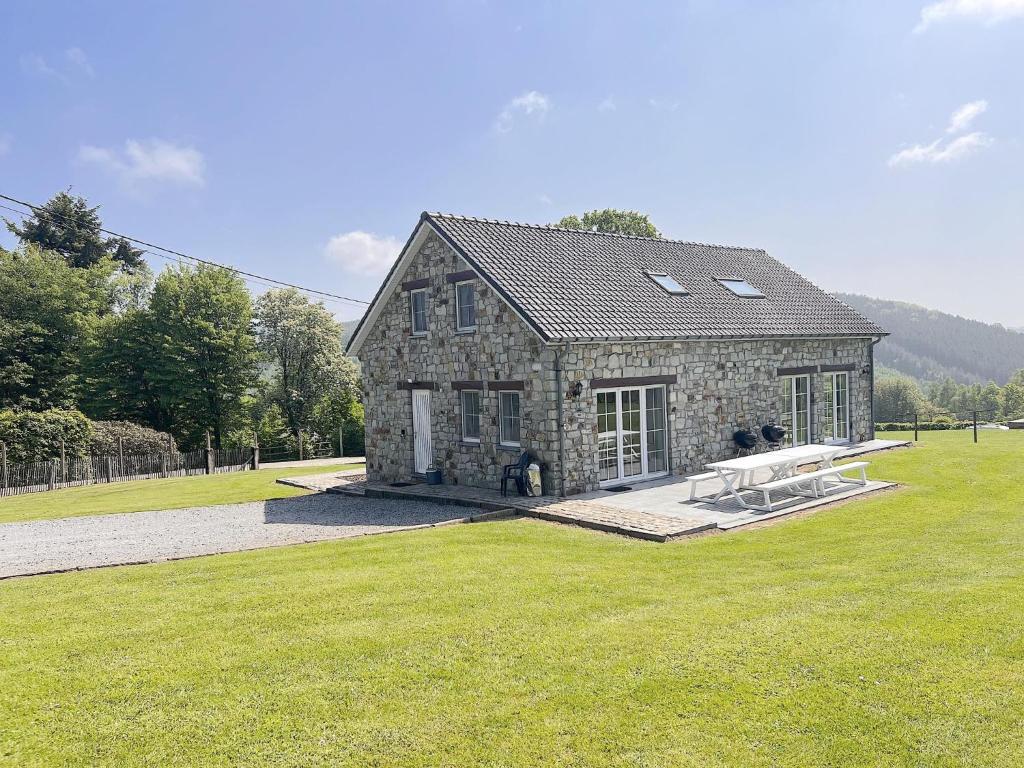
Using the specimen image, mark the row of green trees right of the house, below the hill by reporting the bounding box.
[874,369,1024,422]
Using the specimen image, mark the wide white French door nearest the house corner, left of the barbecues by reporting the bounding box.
[597,386,669,485]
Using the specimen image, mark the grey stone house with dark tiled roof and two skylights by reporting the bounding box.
[348,213,885,495]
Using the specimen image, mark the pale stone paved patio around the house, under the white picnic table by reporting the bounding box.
[280,440,908,542]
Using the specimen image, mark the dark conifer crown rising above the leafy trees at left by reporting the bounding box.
[5,191,145,272]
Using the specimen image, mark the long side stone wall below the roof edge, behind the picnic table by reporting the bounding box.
[564,339,873,494]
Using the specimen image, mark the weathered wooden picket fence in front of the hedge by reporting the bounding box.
[0,446,259,497]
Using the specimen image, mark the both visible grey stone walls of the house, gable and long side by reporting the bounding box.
[359,228,873,494]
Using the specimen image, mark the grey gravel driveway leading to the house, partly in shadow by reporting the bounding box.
[0,494,477,578]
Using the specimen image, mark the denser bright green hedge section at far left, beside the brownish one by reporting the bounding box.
[0,409,92,462]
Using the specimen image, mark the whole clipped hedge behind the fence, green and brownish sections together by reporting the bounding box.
[0,409,176,463]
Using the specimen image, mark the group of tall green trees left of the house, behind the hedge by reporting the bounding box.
[0,193,362,450]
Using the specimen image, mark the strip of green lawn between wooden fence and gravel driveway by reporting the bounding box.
[0,460,362,523]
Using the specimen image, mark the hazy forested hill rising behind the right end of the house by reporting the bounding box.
[836,293,1024,384]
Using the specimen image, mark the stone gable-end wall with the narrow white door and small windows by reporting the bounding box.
[359,233,557,487]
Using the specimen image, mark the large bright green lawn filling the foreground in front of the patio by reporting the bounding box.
[0,432,1024,766]
